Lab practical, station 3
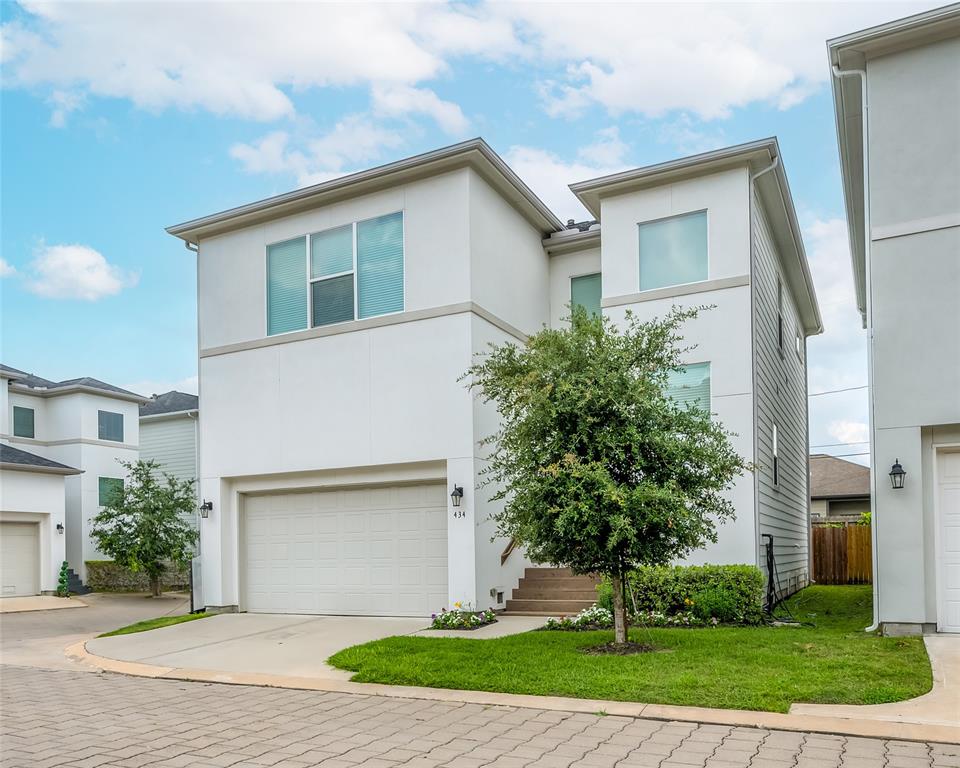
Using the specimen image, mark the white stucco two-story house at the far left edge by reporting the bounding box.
[0,365,146,594]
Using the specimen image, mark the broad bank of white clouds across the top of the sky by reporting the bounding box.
[0,0,936,127]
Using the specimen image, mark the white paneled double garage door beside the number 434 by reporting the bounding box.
[241,485,447,616]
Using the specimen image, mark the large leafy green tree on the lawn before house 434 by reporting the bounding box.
[468,308,745,643]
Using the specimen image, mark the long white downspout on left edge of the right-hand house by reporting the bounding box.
[833,64,880,632]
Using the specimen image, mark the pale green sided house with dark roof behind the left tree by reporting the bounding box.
[140,391,200,482]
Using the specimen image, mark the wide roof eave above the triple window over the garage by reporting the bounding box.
[166,138,563,245]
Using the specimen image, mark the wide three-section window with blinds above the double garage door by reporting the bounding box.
[267,212,404,335]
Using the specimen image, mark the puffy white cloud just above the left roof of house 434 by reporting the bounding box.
[230,115,402,187]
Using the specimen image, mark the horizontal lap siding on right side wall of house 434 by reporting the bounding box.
[753,192,809,594]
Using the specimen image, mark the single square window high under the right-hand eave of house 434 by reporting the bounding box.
[638,211,707,291]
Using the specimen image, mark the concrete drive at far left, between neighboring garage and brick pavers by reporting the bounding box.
[0,593,190,669]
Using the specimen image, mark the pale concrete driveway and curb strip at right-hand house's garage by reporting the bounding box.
[790,635,960,728]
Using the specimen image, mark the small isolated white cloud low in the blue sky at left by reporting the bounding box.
[26,245,139,301]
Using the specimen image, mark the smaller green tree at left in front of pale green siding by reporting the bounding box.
[90,460,197,597]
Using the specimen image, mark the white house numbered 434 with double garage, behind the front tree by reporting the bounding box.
[168,139,821,616]
